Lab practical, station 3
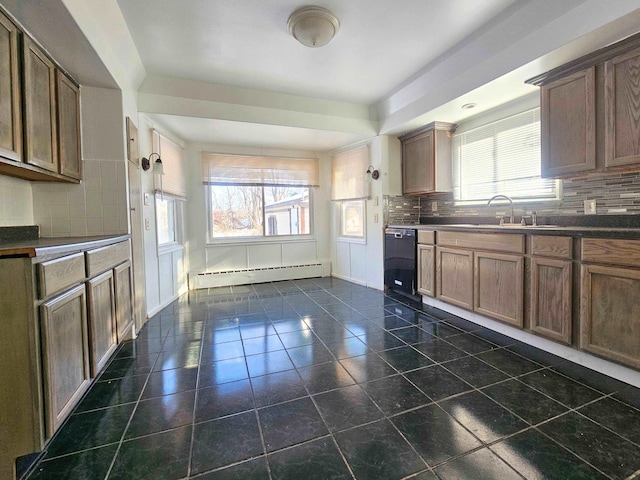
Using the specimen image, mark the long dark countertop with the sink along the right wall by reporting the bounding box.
[388,223,640,239]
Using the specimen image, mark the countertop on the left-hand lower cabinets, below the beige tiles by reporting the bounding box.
[0,234,131,258]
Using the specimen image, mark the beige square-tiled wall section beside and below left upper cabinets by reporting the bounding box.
[33,159,128,237]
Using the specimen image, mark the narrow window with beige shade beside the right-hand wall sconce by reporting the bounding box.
[331,145,370,239]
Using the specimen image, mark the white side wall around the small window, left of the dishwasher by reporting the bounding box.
[331,135,401,290]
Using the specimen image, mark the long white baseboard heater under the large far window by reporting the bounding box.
[190,262,331,289]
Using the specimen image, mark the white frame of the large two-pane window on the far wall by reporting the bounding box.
[203,184,316,245]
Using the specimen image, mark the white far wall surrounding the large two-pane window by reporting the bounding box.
[187,144,330,284]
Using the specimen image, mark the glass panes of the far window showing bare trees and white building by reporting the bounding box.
[207,185,311,238]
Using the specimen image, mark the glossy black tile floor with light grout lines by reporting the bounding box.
[30,278,640,480]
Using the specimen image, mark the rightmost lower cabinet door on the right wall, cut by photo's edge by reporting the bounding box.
[580,265,640,368]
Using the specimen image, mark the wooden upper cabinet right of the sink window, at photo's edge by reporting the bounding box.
[527,33,640,177]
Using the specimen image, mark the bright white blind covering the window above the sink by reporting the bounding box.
[453,108,558,202]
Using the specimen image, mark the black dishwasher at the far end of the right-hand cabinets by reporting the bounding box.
[384,228,417,295]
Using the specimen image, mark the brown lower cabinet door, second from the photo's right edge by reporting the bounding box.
[530,258,572,345]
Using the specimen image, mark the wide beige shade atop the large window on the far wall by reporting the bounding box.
[202,153,320,187]
